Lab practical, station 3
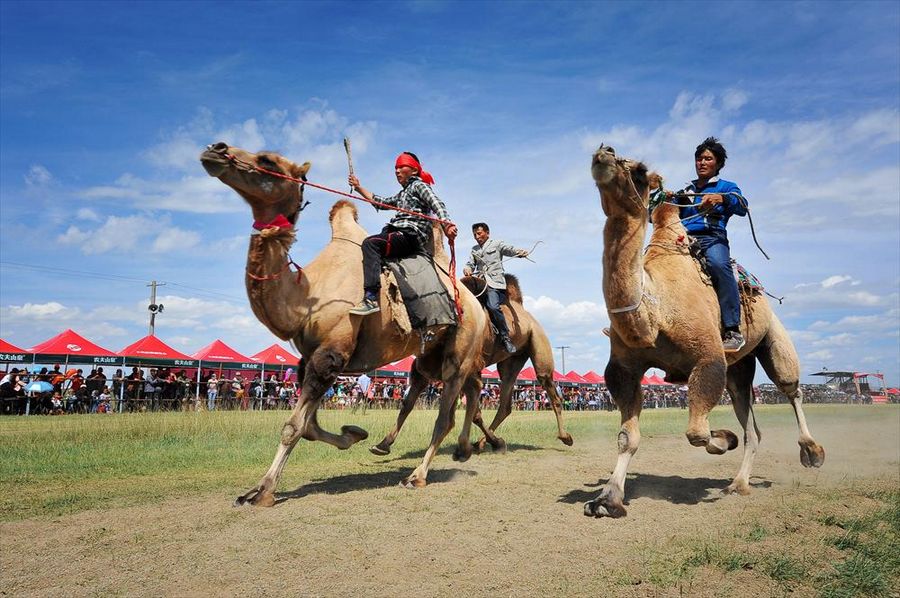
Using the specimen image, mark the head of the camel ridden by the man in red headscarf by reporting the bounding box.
[200,141,310,224]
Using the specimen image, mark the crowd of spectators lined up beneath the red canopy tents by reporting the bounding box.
[0,365,892,414]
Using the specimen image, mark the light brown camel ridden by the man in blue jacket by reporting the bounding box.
[584,145,825,517]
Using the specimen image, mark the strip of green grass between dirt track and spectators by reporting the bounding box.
[0,405,897,521]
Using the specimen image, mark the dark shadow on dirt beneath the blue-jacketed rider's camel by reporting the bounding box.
[557,473,772,505]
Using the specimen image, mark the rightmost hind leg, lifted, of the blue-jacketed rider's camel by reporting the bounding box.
[755,322,825,467]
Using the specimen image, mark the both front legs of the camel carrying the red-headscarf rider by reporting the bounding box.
[234,348,368,507]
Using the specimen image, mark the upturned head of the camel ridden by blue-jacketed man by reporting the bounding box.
[591,145,650,217]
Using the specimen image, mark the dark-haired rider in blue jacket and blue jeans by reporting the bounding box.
[666,137,747,353]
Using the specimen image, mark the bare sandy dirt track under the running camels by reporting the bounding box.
[0,414,900,597]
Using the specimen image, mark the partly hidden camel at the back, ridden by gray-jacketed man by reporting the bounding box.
[369,274,573,455]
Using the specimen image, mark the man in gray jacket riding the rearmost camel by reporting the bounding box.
[463,222,528,354]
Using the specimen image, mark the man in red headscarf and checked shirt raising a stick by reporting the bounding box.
[348,152,457,316]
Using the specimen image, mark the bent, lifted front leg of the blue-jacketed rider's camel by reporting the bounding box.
[686,358,738,455]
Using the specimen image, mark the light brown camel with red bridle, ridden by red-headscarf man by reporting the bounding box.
[200,143,487,506]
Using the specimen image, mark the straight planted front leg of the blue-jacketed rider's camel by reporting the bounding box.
[584,362,644,518]
